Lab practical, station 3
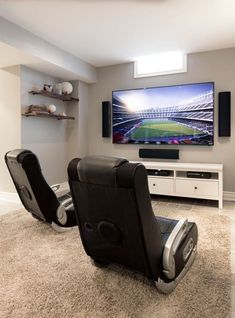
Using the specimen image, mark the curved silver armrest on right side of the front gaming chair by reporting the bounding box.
[163,218,188,279]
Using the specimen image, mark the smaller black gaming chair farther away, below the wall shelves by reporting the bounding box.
[5,149,77,231]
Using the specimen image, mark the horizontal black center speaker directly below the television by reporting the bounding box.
[139,148,179,159]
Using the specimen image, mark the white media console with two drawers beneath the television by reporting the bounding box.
[132,161,223,209]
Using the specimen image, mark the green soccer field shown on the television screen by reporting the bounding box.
[131,119,202,139]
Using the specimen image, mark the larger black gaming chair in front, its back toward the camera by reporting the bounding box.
[68,156,198,293]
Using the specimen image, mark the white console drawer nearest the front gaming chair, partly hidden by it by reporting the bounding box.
[148,177,174,195]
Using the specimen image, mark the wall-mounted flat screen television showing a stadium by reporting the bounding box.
[112,82,214,146]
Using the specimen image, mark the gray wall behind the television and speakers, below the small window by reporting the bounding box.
[88,49,235,192]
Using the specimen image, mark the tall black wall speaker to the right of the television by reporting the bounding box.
[219,92,231,137]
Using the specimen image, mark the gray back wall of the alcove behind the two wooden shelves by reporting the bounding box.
[21,67,78,184]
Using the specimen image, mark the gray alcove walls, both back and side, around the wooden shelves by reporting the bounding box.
[21,67,88,184]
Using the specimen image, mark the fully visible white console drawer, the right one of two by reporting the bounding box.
[176,179,219,198]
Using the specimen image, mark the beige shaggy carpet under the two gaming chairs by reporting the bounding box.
[0,207,231,318]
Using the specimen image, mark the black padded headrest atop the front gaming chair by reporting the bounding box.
[77,156,128,186]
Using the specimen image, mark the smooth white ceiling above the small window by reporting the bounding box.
[0,0,235,66]
